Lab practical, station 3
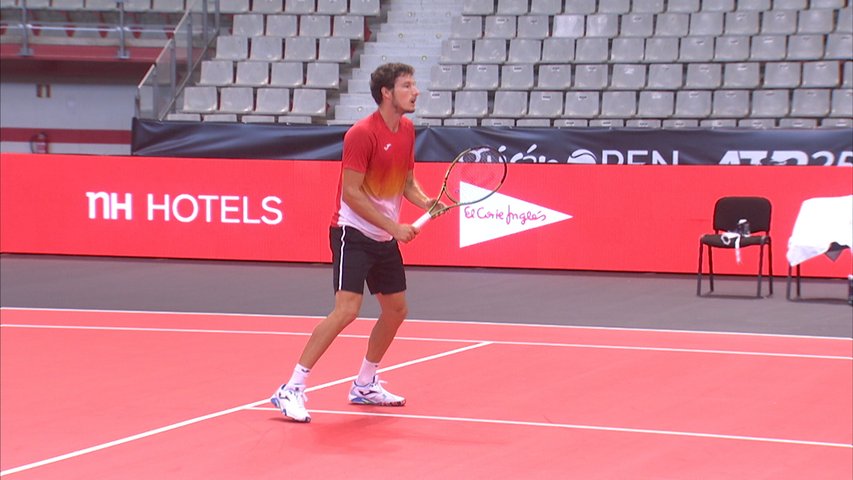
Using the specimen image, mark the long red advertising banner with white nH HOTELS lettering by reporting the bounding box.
[0,154,853,277]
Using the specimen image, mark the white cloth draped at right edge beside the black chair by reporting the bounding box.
[788,195,853,266]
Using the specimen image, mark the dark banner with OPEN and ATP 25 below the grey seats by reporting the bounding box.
[131,119,853,166]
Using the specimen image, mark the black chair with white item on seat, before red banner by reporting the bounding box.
[696,197,773,297]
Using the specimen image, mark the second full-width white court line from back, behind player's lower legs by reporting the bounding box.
[0,323,853,361]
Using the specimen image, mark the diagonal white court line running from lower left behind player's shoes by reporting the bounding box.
[0,342,491,477]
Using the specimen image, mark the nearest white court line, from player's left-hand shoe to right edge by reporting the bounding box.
[249,407,853,449]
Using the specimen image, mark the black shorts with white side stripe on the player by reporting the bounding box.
[329,227,406,295]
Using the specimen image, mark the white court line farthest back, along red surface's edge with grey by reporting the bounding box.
[0,307,853,342]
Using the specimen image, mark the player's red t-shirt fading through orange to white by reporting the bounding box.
[332,110,415,242]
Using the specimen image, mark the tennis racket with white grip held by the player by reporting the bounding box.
[412,146,507,228]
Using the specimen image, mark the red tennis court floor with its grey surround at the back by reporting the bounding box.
[0,256,853,480]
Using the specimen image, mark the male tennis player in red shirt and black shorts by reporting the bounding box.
[270,63,442,422]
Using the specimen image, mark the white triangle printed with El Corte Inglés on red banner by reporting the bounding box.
[459,182,572,248]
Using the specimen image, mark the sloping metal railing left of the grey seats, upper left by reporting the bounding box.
[136,0,220,120]
